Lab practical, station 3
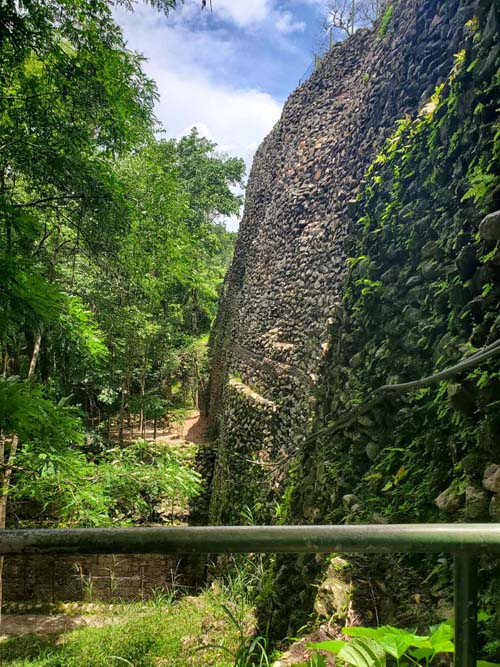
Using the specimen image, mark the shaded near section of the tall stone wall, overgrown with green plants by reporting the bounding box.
[266,2,500,640]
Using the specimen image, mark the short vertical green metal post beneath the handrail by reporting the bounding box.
[454,554,478,667]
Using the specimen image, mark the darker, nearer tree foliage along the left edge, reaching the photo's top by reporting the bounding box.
[0,2,155,521]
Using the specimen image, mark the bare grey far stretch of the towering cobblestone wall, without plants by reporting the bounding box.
[209,0,480,523]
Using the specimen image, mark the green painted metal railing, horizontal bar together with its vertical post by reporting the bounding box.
[0,524,500,667]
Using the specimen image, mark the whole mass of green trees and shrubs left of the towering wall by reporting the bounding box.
[0,0,244,536]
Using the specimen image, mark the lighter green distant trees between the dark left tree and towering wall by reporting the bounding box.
[76,132,243,440]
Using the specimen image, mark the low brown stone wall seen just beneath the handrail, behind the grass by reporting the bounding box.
[3,554,195,603]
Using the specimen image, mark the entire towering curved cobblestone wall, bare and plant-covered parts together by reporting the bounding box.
[210,0,500,658]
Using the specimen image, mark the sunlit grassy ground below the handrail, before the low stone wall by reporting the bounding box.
[1,588,252,667]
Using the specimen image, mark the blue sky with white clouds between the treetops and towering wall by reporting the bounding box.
[115,0,326,228]
